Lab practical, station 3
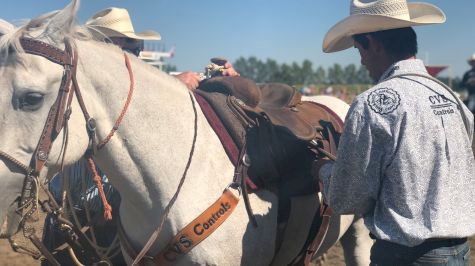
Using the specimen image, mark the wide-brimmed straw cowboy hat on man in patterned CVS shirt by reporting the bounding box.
[323,0,445,53]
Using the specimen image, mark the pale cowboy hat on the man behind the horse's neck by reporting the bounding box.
[86,7,161,40]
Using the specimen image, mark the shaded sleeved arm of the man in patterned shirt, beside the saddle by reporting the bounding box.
[319,109,384,214]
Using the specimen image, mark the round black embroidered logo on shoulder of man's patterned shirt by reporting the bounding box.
[368,88,401,115]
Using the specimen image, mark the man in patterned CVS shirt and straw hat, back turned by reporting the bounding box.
[315,0,475,265]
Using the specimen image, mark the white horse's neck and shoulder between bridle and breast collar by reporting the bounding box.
[78,39,233,247]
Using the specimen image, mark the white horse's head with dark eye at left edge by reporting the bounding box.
[0,1,91,236]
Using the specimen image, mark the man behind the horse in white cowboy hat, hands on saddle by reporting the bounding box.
[86,7,239,89]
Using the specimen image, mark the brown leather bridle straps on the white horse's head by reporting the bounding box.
[0,38,96,265]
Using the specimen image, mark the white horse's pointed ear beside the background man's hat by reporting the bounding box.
[39,0,80,42]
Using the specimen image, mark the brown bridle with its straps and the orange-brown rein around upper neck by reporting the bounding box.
[0,38,134,265]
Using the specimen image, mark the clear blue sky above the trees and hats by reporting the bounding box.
[0,0,475,76]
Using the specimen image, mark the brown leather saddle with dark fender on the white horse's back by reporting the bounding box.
[196,77,343,264]
